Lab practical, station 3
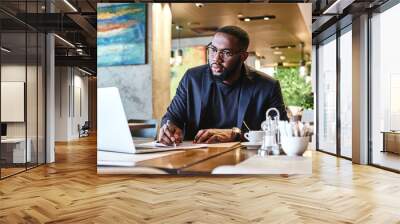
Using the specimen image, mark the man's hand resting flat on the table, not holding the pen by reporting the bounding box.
[193,129,235,144]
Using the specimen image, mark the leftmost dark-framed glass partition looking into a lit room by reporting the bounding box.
[0,1,46,178]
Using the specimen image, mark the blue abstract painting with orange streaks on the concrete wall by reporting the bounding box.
[97,3,146,67]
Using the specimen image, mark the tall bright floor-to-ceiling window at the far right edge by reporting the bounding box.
[370,4,400,170]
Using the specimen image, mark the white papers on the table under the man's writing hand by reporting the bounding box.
[135,141,208,153]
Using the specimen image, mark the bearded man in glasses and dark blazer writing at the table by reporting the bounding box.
[158,26,287,145]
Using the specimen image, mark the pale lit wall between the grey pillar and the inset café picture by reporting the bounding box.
[55,67,88,141]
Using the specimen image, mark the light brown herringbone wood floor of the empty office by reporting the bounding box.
[0,134,400,224]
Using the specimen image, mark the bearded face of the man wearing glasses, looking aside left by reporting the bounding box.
[208,33,244,76]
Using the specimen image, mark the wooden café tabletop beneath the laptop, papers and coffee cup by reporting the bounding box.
[97,141,312,175]
